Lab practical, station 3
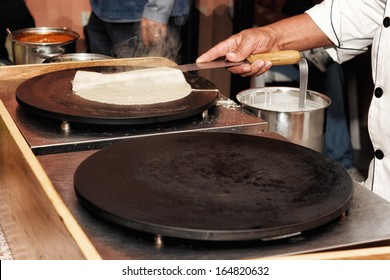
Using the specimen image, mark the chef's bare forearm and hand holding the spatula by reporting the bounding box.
[197,14,332,76]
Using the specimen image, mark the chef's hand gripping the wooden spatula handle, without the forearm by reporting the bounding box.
[196,27,281,77]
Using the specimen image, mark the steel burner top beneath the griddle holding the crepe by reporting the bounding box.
[0,85,267,154]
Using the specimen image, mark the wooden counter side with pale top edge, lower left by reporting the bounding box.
[0,100,101,260]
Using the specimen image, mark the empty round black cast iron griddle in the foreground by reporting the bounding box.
[74,132,353,241]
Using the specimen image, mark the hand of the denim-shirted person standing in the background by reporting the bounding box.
[141,18,167,47]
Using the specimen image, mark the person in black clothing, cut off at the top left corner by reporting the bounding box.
[0,0,35,65]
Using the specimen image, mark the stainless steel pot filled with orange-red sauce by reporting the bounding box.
[8,27,80,64]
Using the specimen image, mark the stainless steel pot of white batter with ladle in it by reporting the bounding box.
[237,87,331,152]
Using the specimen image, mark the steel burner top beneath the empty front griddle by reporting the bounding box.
[38,148,390,259]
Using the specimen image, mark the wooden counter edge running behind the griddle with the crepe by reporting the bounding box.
[0,57,177,81]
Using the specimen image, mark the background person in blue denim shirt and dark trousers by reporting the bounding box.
[86,0,192,61]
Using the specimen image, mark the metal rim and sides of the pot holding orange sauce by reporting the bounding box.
[8,27,80,64]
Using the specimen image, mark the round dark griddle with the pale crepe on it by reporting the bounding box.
[16,66,219,125]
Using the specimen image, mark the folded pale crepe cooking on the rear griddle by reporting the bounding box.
[72,67,192,105]
